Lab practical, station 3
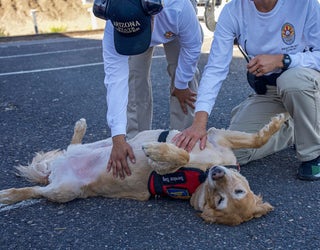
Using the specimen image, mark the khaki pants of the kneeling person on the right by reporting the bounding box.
[229,68,320,164]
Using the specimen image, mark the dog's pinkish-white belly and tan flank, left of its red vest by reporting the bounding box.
[49,145,152,200]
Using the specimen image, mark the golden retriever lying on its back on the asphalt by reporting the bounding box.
[0,114,286,225]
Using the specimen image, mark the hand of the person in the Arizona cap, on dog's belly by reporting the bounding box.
[107,135,136,179]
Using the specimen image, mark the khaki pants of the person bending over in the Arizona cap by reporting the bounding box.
[127,38,200,138]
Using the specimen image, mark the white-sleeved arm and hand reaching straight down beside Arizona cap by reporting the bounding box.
[103,22,135,179]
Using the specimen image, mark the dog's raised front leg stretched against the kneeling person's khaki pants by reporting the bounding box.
[208,113,288,149]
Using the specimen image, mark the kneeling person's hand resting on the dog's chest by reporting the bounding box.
[172,111,208,152]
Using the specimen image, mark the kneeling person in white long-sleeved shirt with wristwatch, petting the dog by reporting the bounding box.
[174,0,320,180]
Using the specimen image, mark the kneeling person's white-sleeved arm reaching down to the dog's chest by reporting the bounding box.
[173,3,234,152]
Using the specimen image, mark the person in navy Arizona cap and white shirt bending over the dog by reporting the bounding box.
[99,0,202,179]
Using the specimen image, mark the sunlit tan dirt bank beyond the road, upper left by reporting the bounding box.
[0,0,105,36]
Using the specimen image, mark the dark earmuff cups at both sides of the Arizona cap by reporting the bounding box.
[92,0,163,20]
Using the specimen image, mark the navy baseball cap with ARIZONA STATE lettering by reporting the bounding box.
[106,0,151,55]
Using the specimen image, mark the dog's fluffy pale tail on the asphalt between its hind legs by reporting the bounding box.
[15,150,62,185]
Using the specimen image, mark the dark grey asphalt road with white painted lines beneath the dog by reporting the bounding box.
[0,23,320,249]
